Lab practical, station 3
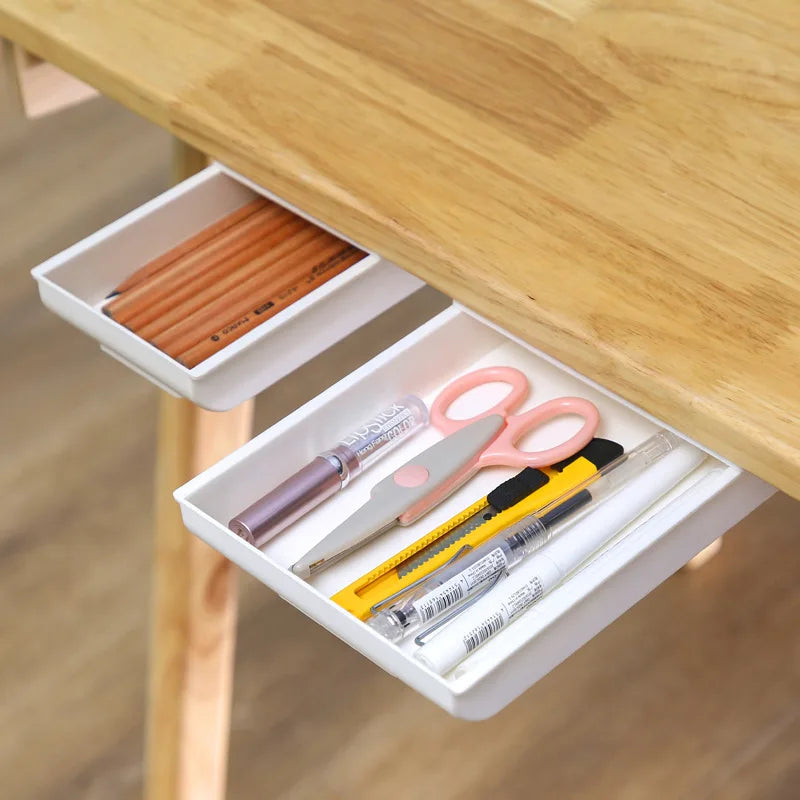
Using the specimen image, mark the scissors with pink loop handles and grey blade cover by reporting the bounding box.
[292,367,600,578]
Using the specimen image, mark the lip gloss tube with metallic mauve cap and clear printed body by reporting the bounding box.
[228,394,428,547]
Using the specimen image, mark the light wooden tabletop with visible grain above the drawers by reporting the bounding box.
[0,0,800,497]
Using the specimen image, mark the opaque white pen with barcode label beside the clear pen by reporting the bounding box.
[414,444,705,675]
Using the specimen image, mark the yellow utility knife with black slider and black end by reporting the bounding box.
[331,439,623,619]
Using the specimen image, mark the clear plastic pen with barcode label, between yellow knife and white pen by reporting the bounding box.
[367,431,679,642]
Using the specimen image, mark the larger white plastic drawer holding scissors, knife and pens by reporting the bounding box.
[170,305,773,719]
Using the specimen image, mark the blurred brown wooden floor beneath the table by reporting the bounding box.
[0,89,800,800]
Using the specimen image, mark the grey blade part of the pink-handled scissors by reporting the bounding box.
[292,414,505,578]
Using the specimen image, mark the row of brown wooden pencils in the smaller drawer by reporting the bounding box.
[103,198,365,368]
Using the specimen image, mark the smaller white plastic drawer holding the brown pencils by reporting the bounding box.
[33,164,424,411]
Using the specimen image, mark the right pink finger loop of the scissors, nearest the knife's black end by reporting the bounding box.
[478,397,600,467]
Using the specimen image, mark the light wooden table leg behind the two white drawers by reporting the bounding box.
[145,141,253,800]
